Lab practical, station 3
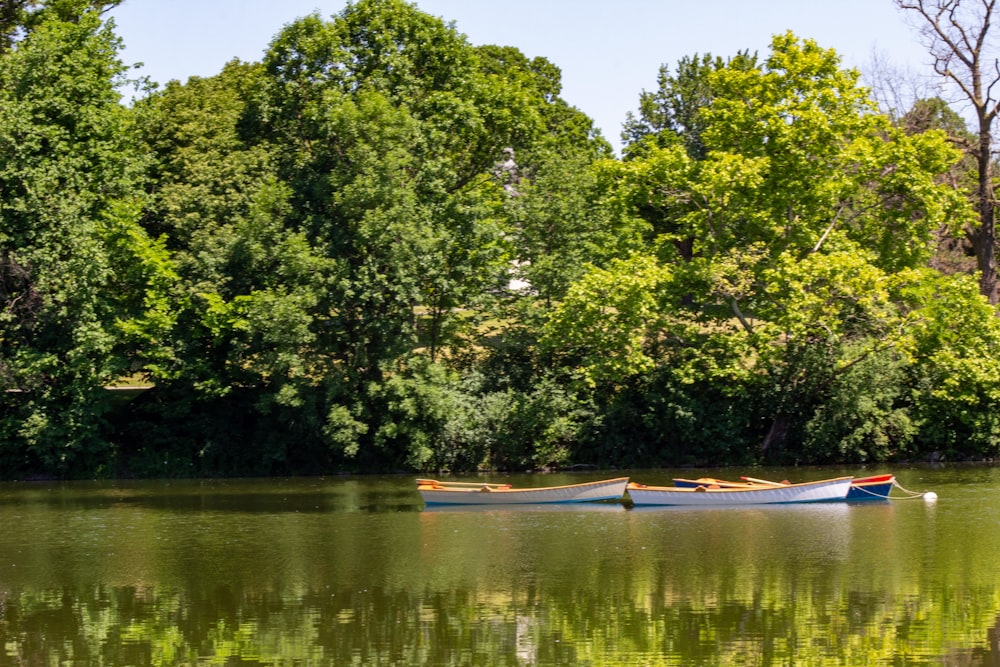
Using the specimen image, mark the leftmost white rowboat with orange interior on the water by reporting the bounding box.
[417,477,628,505]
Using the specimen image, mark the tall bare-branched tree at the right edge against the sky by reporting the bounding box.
[896,0,1000,304]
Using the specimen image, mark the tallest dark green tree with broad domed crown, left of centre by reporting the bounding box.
[247,0,606,470]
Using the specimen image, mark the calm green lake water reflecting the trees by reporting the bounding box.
[0,466,1000,665]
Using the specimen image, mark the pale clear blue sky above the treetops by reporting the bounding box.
[112,0,928,148]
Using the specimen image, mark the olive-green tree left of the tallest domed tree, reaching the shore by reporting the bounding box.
[126,61,330,474]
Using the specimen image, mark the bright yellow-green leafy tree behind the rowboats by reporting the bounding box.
[564,34,967,458]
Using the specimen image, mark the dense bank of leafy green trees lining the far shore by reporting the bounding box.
[0,0,1000,477]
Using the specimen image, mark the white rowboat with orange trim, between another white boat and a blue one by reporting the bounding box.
[628,477,854,506]
